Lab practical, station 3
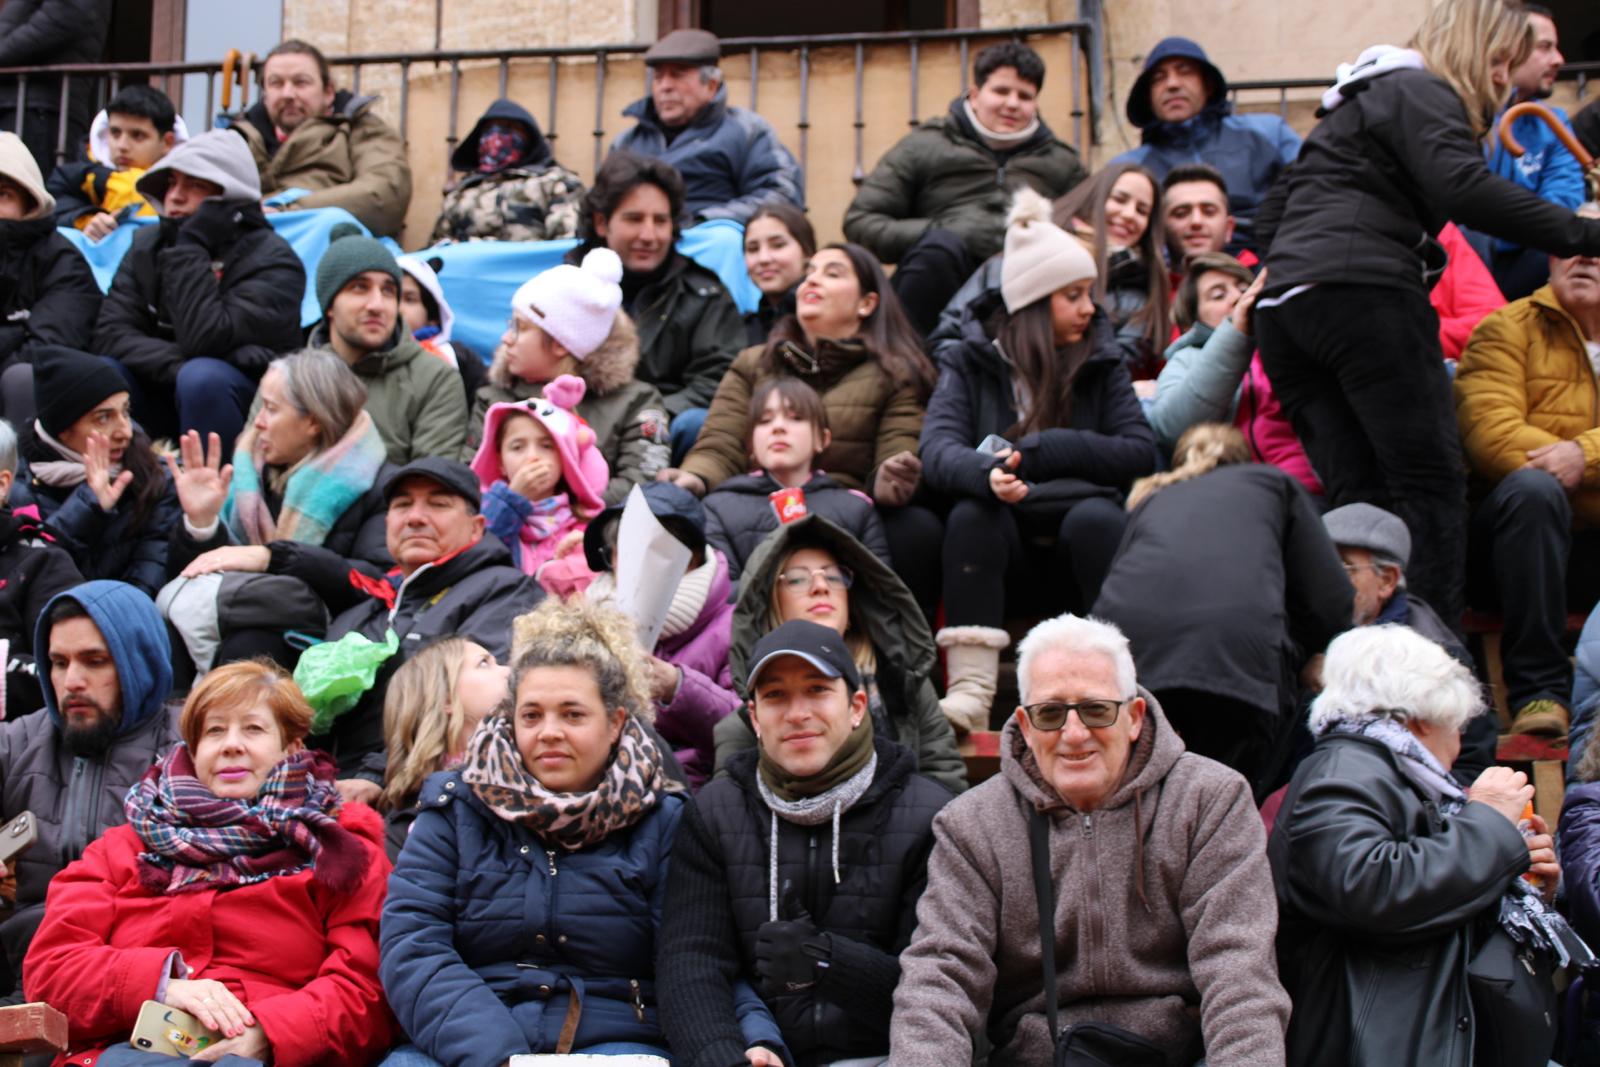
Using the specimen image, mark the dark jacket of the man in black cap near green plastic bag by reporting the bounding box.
[270,536,544,777]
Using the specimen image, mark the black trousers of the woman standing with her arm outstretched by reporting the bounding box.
[1256,285,1467,629]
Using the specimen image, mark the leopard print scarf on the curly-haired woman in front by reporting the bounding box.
[461,715,683,851]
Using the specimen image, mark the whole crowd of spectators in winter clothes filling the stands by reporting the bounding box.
[0,0,1600,1067]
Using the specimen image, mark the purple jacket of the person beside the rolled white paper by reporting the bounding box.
[656,556,739,789]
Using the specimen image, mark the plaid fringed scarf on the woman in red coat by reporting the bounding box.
[123,742,366,893]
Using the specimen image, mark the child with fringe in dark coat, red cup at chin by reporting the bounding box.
[706,378,890,579]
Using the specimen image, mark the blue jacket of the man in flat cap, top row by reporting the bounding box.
[611,85,805,226]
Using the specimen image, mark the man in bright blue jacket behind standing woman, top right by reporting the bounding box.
[1470,3,1584,301]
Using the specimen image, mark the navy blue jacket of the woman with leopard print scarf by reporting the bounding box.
[381,771,778,1067]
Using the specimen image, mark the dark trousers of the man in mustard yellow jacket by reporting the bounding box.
[1469,470,1600,712]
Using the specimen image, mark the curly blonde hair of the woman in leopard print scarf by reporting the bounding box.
[507,597,656,723]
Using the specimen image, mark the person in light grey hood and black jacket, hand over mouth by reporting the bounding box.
[94,130,306,446]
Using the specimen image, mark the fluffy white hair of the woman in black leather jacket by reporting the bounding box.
[1309,624,1483,734]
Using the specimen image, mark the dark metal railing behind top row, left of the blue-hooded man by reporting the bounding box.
[0,21,1099,199]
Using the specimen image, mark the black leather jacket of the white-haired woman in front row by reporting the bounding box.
[1267,734,1544,1067]
